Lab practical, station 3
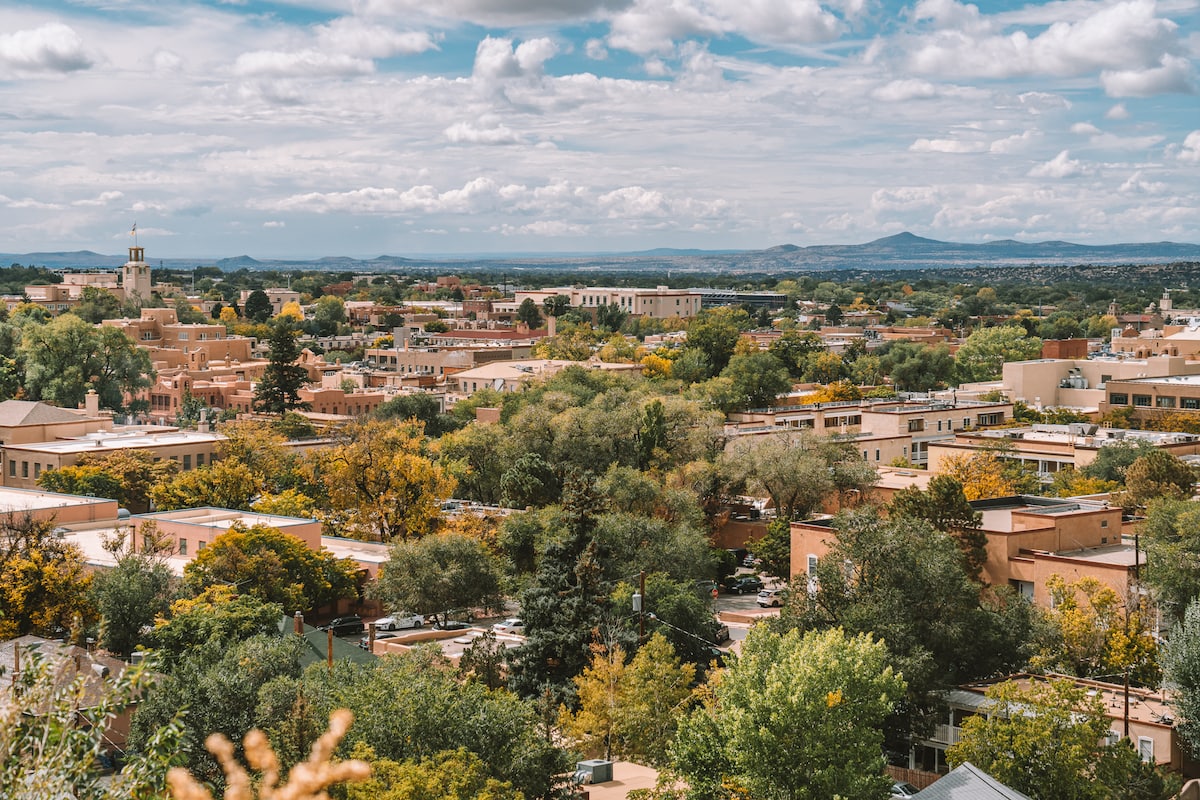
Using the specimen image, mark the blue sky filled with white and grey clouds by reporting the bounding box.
[0,0,1200,260]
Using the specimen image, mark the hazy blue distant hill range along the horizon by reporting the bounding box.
[0,233,1200,273]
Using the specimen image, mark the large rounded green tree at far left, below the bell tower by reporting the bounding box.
[18,314,155,411]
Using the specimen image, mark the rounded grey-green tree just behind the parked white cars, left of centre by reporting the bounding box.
[373,534,500,620]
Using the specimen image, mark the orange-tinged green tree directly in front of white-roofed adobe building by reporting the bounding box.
[177,524,356,610]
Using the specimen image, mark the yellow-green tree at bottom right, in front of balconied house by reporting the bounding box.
[946,680,1177,800]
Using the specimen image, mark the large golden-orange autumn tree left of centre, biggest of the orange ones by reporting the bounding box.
[312,420,455,542]
